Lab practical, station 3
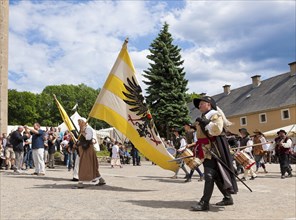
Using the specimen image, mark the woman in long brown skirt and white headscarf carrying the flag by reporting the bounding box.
[76,118,106,188]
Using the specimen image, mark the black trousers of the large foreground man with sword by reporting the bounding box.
[201,158,231,203]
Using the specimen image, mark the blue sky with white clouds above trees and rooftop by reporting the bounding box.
[9,0,296,95]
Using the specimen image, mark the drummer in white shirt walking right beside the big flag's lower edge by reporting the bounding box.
[172,128,189,179]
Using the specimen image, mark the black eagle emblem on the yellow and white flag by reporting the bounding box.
[122,76,161,145]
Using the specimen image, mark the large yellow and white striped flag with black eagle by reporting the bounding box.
[89,41,178,171]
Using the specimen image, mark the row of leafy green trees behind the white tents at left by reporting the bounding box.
[8,84,110,130]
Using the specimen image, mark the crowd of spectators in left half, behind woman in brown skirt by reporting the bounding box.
[0,126,141,173]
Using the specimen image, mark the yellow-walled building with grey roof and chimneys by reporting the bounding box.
[189,62,296,134]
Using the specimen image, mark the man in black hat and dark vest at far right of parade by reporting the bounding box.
[274,130,292,179]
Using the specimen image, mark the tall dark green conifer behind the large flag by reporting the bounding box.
[143,23,189,137]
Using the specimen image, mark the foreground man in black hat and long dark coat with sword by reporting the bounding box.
[191,96,238,211]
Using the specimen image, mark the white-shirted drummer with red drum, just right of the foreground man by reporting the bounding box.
[238,128,257,181]
